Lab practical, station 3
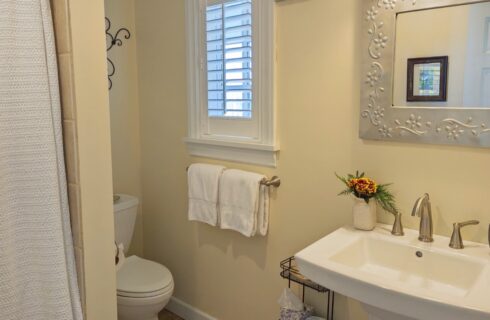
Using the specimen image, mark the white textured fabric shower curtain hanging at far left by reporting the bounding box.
[0,0,82,320]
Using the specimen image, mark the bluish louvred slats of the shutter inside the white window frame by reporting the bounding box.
[206,0,252,119]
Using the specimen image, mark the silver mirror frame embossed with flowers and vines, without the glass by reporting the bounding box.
[359,0,490,147]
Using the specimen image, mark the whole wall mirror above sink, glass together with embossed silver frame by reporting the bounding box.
[359,0,490,147]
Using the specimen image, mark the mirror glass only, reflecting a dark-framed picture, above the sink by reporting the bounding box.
[393,2,490,108]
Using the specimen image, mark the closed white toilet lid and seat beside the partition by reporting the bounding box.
[117,256,173,293]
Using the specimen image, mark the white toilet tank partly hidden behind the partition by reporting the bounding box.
[114,194,139,253]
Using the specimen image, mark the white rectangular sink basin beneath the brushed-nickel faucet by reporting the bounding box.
[296,224,490,320]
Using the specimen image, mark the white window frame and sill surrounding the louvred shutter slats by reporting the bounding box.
[185,0,279,167]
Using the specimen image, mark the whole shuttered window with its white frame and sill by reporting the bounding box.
[186,0,278,166]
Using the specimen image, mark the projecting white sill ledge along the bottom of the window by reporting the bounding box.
[184,138,279,168]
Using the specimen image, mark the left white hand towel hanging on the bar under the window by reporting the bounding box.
[187,163,225,226]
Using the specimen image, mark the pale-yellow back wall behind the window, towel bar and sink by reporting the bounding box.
[136,0,490,320]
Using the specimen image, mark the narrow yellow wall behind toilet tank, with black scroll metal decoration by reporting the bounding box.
[105,0,143,255]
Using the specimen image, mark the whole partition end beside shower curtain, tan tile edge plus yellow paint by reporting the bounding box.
[51,0,116,320]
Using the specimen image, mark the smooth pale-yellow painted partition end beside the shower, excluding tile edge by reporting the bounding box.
[69,0,116,320]
